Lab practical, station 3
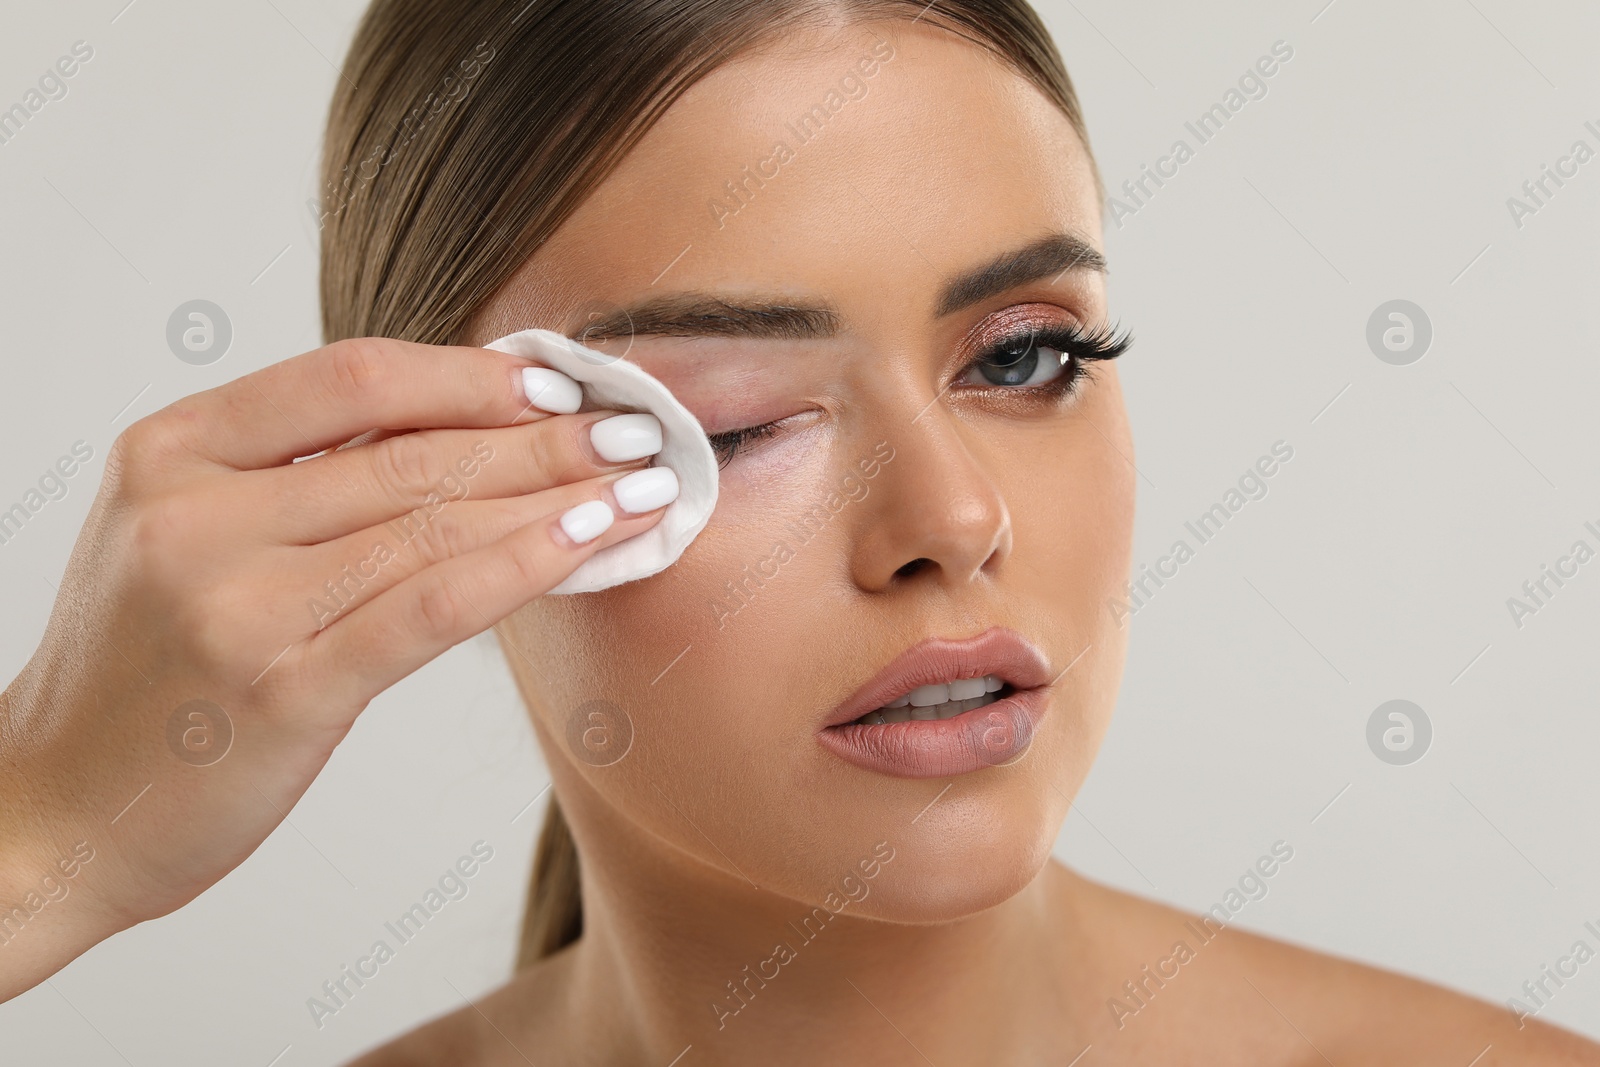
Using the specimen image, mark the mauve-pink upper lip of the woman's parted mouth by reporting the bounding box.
[824,625,1053,726]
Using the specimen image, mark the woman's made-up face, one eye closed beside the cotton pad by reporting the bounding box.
[469,21,1133,921]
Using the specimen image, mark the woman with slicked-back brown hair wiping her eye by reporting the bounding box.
[0,0,1600,1067]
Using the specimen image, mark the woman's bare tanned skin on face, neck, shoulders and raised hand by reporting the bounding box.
[0,10,1600,1067]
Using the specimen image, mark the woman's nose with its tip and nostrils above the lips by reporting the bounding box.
[851,405,1011,592]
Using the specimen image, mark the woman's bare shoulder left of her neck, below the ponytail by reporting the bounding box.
[347,947,574,1067]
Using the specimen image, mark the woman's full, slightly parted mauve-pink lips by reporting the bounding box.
[818,627,1054,777]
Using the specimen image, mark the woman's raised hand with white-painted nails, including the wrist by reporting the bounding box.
[0,339,677,1000]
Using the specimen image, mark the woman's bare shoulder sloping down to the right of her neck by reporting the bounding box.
[1067,875,1600,1067]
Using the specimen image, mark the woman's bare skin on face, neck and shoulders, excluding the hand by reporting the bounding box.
[358,21,1600,1067]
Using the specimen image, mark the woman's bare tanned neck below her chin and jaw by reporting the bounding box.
[556,806,1088,1064]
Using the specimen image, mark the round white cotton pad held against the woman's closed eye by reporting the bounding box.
[483,330,717,593]
